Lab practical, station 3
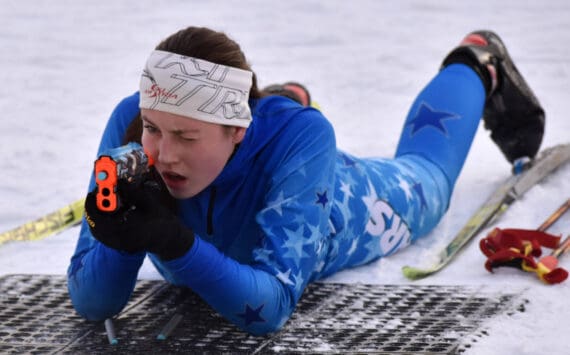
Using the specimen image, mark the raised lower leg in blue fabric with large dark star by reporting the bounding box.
[396,64,486,195]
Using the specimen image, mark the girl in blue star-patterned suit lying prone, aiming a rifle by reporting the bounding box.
[68,27,544,334]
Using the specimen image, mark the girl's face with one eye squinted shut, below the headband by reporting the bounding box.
[141,109,246,199]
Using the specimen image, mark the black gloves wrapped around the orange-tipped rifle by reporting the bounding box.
[85,180,194,260]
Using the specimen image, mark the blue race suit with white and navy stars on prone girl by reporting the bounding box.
[68,64,485,334]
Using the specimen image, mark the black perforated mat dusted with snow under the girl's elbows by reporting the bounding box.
[0,275,528,354]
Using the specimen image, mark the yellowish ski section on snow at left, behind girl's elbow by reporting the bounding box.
[0,199,85,245]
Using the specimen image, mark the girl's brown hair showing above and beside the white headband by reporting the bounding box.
[123,26,264,143]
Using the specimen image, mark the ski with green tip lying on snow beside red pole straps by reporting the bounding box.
[402,144,570,280]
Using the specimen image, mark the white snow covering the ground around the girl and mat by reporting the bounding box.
[0,0,570,354]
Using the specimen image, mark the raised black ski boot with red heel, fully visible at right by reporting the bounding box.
[442,31,544,163]
